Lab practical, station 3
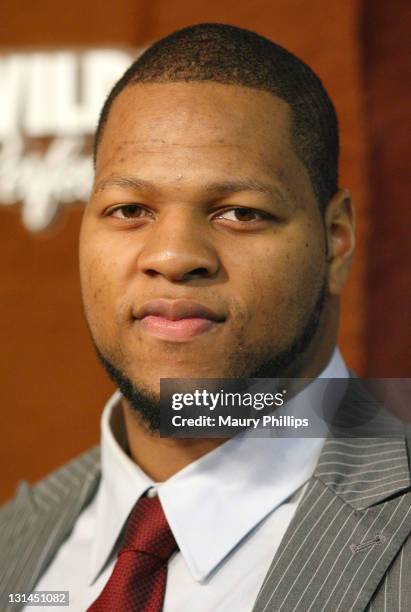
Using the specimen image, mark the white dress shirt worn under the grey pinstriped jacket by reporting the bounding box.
[32,349,348,612]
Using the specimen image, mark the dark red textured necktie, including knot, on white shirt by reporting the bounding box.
[88,496,177,612]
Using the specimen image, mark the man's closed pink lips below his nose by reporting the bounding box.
[136,299,225,342]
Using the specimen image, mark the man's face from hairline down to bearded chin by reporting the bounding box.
[80,83,326,394]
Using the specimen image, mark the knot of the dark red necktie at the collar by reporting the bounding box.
[120,496,177,561]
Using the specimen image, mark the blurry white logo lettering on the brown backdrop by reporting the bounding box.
[0,49,137,231]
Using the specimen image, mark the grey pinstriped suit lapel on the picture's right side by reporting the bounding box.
[253,383,411,612]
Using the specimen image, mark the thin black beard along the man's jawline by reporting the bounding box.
[93,280,327,434]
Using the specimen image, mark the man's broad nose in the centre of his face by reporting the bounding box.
[138,211,219,282]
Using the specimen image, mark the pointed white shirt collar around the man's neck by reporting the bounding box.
[91,349,349,581]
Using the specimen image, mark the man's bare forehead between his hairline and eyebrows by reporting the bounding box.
[99,82,291,165]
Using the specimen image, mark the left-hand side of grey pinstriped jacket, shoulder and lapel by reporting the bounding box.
[0,447,100,610]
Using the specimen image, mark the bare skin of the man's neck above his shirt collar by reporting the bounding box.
[122,304,338,482]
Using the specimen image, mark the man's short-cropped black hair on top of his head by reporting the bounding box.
[94,23,339,210]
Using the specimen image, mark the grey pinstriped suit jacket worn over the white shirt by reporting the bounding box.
[0,383,411,612]
